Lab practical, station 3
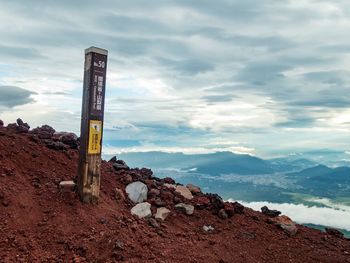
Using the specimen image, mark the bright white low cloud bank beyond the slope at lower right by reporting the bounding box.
[241,202,350,231]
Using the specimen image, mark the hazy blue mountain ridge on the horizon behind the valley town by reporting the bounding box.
[108,151,317,175]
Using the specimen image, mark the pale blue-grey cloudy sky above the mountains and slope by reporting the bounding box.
[0,0,350,157]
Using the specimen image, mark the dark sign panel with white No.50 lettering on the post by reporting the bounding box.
[90,53,107,117]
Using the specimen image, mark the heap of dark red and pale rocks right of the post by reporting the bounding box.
[109,157,244,224]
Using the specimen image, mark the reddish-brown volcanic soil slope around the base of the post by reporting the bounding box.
[0,122,350,263]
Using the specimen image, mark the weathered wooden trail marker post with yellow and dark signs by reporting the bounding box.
[77,47,108,203]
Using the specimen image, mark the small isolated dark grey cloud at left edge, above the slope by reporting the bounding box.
[0,86,35,108]
